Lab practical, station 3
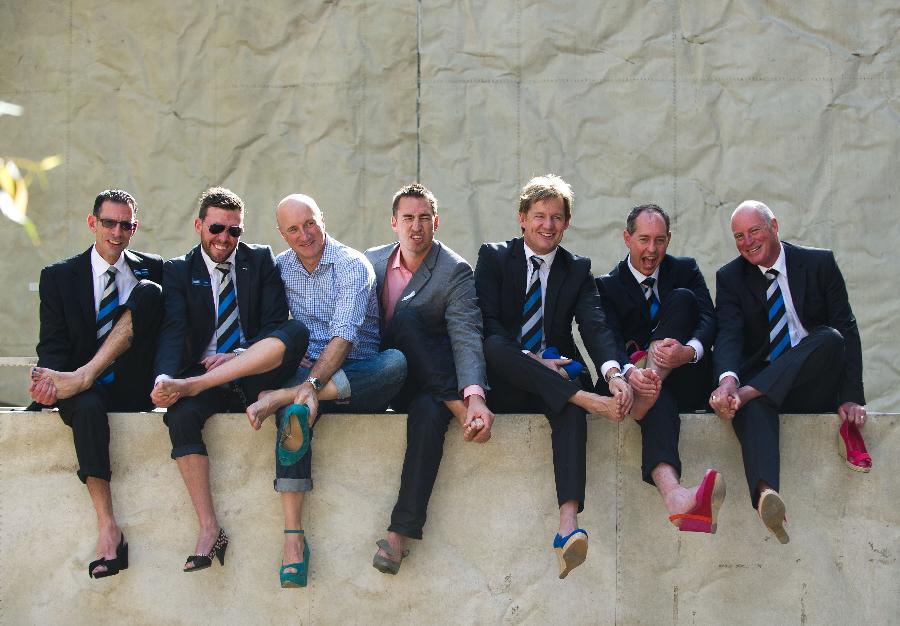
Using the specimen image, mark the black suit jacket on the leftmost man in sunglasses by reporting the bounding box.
[37,246,163,372]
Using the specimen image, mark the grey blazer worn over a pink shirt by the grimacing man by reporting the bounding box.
[366,239,488,391]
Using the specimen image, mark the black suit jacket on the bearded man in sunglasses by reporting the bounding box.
[155,242,288,377]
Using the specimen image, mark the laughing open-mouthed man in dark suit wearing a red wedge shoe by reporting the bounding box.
[597,204,725,533]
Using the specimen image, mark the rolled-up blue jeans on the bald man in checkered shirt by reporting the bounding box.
[275,349,406,492]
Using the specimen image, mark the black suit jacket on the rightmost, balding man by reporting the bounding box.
[713,242,865,404]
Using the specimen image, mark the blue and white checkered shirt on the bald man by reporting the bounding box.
[275,235,380,361]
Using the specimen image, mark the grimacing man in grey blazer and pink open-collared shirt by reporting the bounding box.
[366,183,494,574]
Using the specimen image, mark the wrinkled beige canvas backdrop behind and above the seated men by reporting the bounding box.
[0,0,900,404]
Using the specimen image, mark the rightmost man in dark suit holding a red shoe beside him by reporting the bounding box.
[710,200,866,543]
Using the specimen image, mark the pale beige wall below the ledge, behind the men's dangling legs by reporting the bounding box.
[0,412,900,625]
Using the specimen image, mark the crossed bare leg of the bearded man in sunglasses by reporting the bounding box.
[156,337,284,398]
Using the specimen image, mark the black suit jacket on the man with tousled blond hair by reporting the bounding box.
[475,237,627,384]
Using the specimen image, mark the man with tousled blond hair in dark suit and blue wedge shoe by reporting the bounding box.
[475,174,655,578]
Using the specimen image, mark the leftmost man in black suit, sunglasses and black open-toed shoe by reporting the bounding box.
[30,189,163,578]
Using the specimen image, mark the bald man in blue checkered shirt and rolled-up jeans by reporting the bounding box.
[247,194,406,573]
